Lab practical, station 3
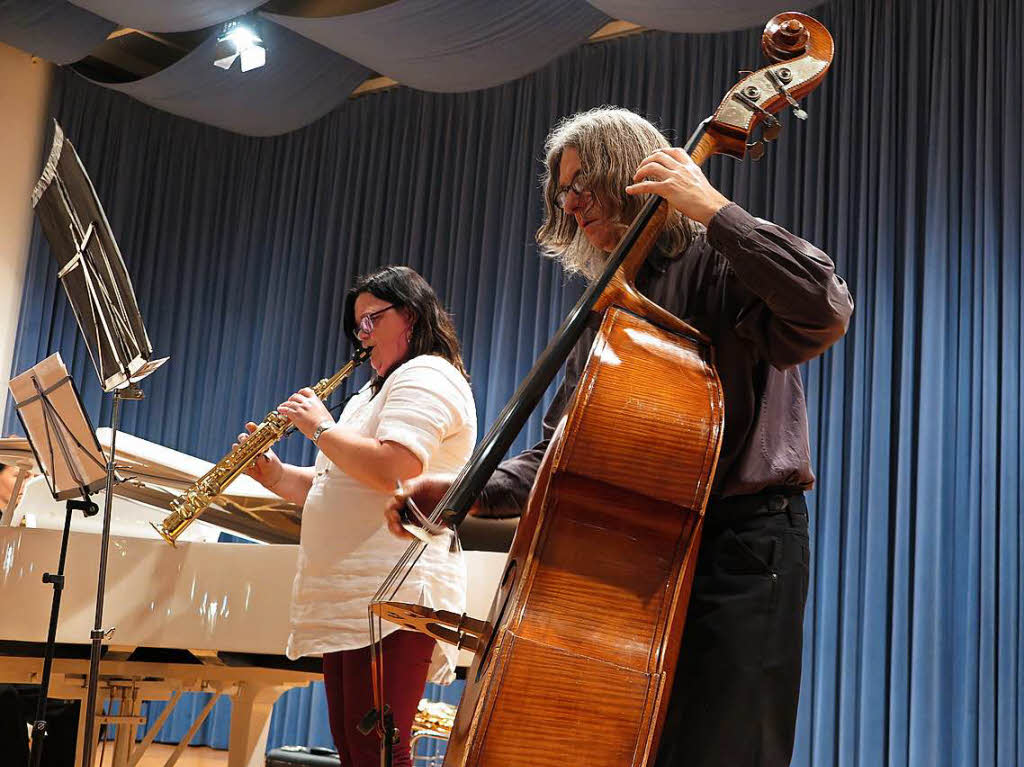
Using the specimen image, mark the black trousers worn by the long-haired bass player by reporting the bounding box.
[655,493,810,767]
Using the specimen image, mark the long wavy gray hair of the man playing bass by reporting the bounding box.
[537,106,699,280]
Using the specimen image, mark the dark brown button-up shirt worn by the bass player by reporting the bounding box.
[481,204,853,516]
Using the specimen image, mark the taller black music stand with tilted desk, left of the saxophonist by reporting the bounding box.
[32,121,167,767]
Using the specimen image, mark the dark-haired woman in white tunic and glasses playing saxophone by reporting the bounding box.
[239,266,476,767]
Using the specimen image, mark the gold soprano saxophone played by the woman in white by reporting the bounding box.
[153,348,370,546]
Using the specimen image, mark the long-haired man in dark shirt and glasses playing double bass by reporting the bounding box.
[388,108,853,767]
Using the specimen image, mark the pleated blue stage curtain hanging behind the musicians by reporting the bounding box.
[7,0,1024,767]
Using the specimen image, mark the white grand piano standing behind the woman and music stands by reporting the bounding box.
[0,429,514,767]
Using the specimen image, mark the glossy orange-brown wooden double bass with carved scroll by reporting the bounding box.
[370,12,834,767]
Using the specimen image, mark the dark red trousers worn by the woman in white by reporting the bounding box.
[324,631,435,767]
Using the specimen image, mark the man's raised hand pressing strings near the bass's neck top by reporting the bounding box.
[626,147,729,226]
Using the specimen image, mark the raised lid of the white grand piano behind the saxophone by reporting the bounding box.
[0,427,300,544]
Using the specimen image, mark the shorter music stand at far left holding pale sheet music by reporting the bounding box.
[9,354,106,767]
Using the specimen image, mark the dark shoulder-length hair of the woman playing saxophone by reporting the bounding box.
[344,266,469,394]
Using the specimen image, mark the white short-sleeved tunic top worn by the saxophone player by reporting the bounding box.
[287,354,476,682]
